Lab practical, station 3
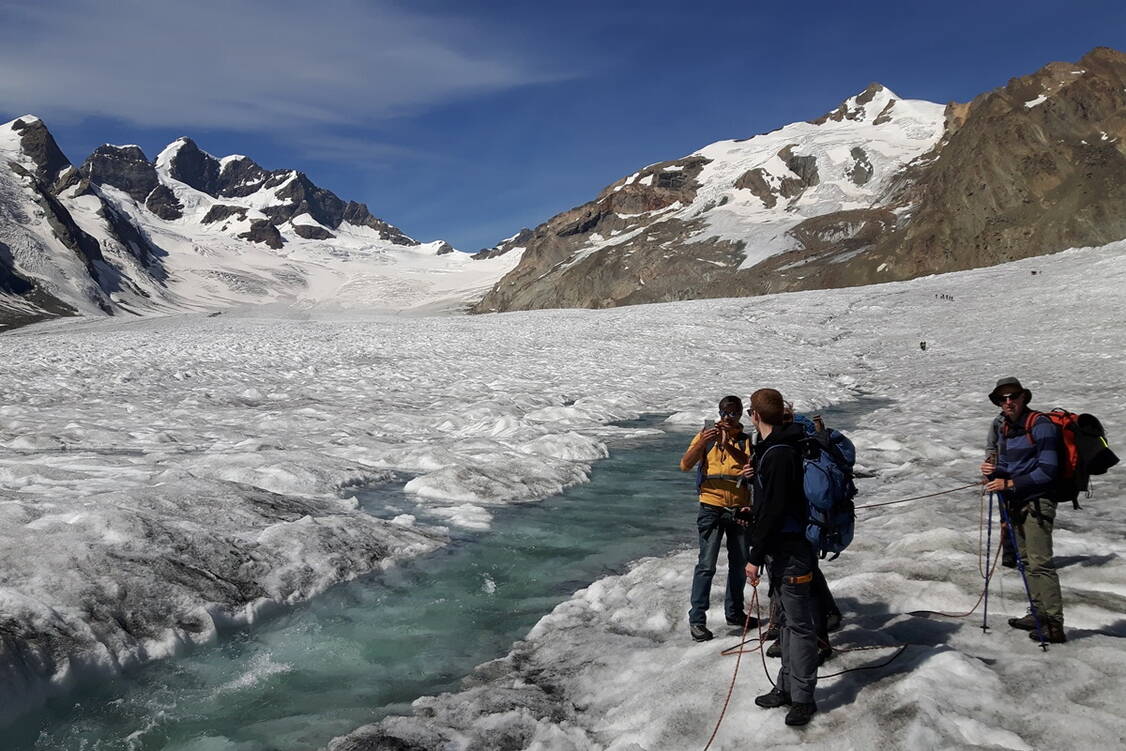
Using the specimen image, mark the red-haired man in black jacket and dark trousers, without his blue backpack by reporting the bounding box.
[744,388,817,725]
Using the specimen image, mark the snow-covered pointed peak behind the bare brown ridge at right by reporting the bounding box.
[476,83,945,312]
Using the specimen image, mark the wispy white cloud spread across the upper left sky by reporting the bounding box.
[0,0,560,131]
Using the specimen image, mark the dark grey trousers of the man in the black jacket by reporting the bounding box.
[767,539,817,703]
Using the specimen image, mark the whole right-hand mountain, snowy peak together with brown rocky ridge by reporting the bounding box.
[475,47,1126,312]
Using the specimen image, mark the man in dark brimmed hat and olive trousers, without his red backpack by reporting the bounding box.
[981,377,1067,644]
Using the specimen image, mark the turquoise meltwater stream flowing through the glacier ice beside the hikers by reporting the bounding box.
[10,405,869,751]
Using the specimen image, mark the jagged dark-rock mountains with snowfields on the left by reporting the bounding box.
[0,121,519,324]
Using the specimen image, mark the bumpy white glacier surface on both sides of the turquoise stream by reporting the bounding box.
[0,242,1126,751]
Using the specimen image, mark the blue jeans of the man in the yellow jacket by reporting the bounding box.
[688,503,747,626]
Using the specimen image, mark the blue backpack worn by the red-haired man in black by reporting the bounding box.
[794,414,856,561]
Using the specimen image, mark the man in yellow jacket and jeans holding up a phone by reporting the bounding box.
[680,396,758,642]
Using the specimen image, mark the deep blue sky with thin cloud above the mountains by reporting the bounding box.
[0,0,1126,250]
